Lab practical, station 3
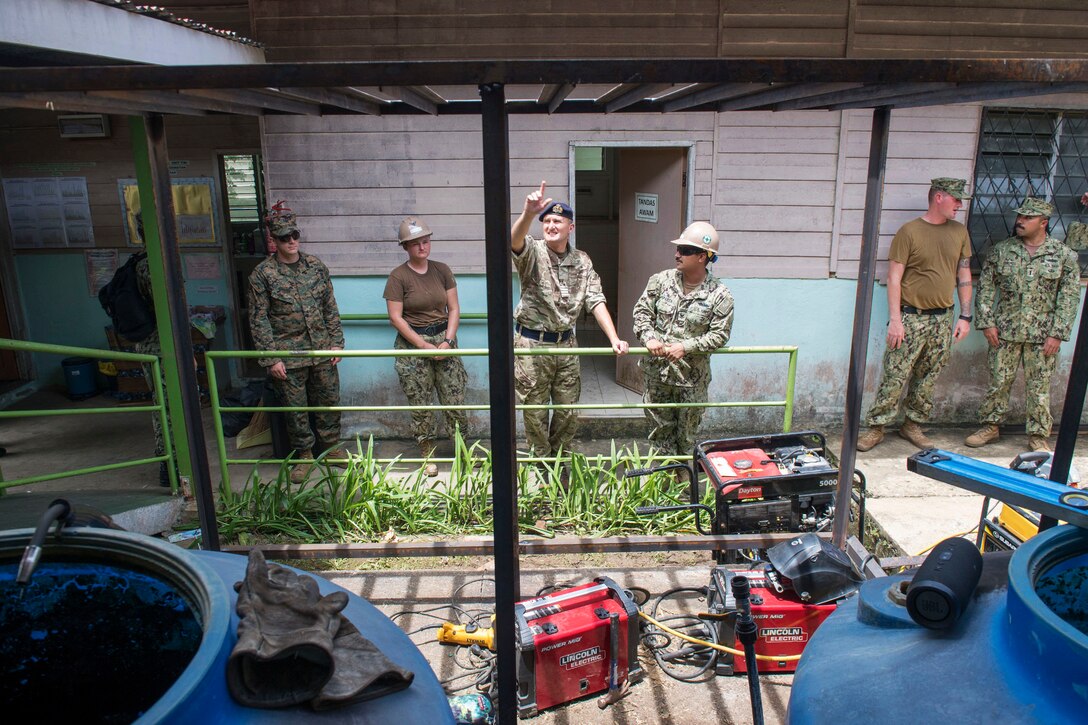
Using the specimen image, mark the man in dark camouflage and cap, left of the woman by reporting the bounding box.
[249,205,347,483]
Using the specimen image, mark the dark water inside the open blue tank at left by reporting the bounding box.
[0,563,203,723]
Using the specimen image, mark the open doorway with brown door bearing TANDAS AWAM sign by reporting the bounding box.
[571,144,692,416]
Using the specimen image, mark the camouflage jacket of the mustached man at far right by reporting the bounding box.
[975,236,1080,343]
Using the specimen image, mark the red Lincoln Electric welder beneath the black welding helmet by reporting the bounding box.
[707,566,836,675]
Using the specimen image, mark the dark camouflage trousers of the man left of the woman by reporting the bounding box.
[271,361,339,455]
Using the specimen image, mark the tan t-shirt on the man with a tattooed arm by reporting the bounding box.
[888,217,970,309]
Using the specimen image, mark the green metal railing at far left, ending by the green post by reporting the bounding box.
[0,339,177,493]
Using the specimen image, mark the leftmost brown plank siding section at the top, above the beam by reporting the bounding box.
[250,0,718,61]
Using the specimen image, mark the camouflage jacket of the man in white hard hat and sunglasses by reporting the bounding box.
[633,269,733,386]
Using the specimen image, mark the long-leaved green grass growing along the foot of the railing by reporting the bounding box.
[219,428,695,544]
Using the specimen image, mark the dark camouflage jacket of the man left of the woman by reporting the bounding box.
[249,254,344,368]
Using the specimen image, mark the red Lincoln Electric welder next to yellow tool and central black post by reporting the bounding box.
[514,577,643,717]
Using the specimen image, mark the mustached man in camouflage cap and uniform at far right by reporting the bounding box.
[964,198,1080,451]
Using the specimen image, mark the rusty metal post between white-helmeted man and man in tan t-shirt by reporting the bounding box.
[831,106,891,549]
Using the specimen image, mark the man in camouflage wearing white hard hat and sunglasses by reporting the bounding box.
[633,222,733,455]
